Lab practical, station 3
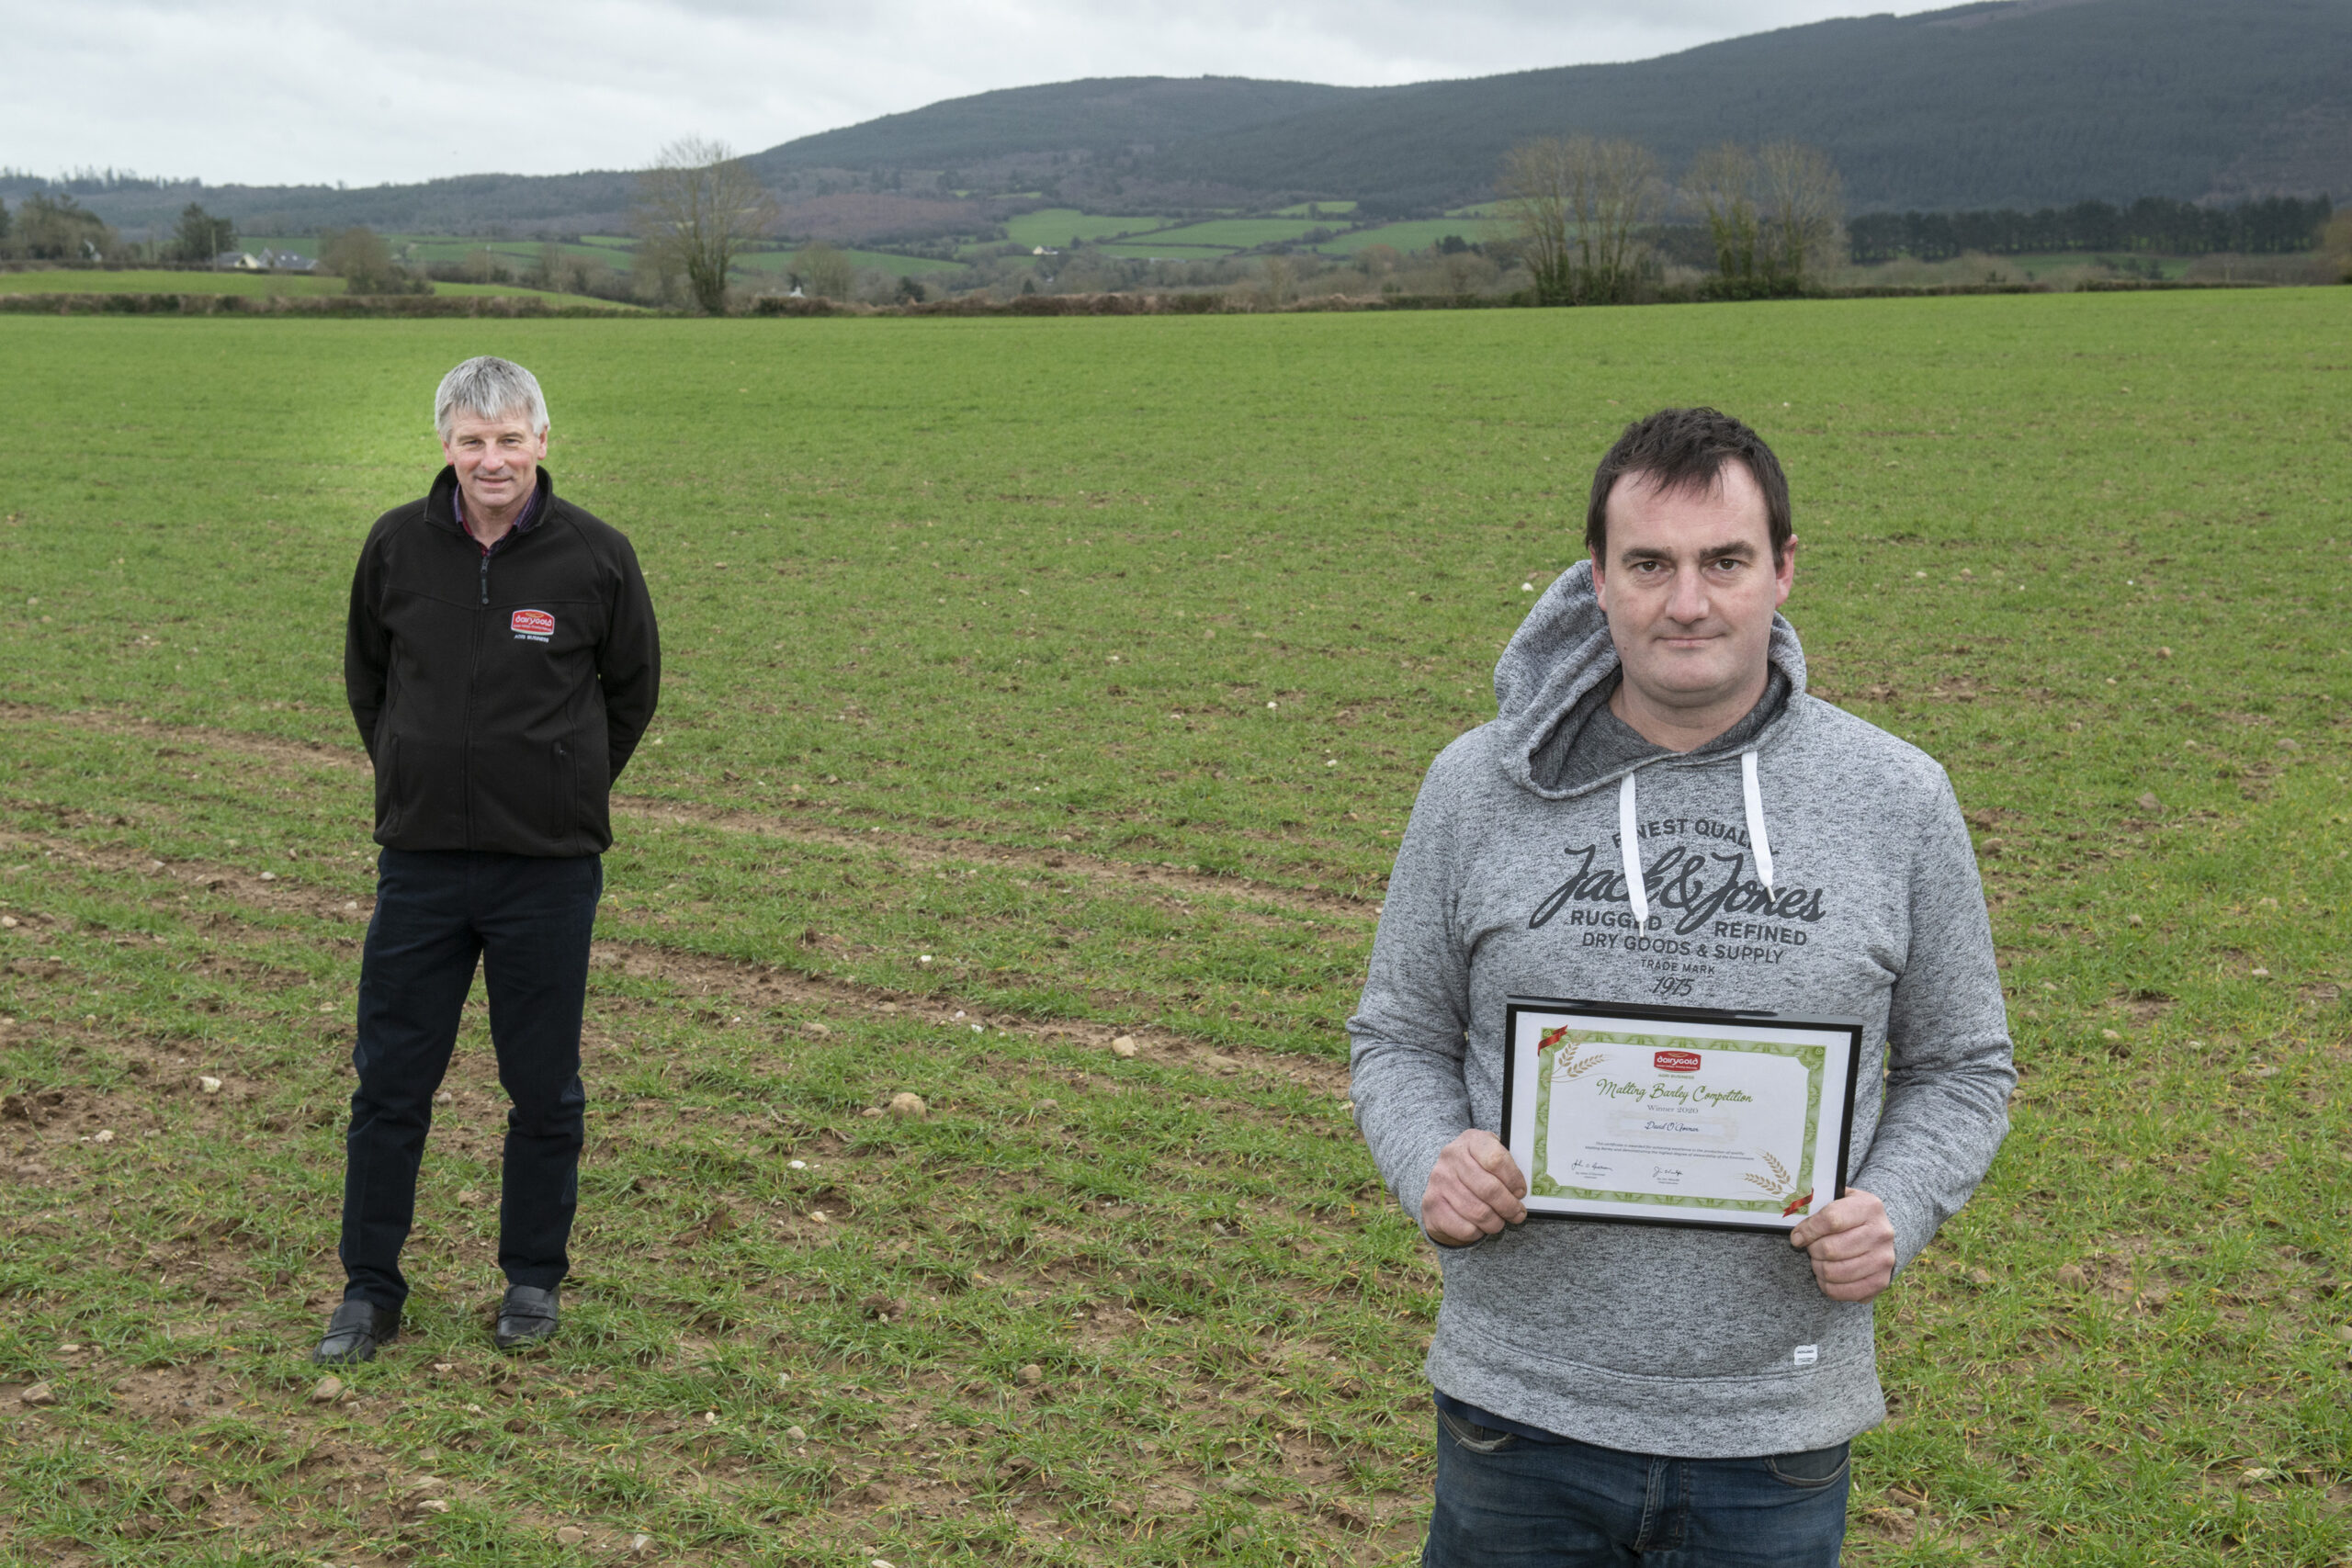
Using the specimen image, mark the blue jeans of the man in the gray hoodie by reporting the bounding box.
[1420,1411,1851,1568]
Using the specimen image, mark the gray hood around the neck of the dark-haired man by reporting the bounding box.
[1494,559,1804,799]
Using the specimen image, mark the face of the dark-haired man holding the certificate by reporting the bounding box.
[1592,463,1797,710]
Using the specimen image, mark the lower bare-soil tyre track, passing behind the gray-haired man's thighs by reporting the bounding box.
[0,832,1348,1096]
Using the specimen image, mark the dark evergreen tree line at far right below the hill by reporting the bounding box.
[1847,195,2334,264]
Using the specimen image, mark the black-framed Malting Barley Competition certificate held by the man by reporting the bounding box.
[1503,997,1863,1232]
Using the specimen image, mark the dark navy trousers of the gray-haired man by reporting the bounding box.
[341,849,605,1312]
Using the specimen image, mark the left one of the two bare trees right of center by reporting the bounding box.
[1498,136,1665,306]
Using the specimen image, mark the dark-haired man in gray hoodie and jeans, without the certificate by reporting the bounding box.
[1348,409,2016,1568]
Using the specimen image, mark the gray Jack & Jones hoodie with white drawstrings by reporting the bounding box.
[1348,562,2016,1458]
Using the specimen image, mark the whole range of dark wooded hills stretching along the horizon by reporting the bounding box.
[14,0,2352,240]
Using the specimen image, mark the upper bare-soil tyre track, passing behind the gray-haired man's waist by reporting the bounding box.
[0,703,1381,919]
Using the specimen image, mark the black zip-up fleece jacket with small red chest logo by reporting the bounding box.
[344,468,661,856]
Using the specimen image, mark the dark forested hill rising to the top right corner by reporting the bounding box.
[1148,0,2352,209]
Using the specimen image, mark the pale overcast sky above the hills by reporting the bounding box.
[0,0,1933,186]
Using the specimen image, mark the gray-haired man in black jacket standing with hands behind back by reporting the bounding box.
[312,357,661,1361]
